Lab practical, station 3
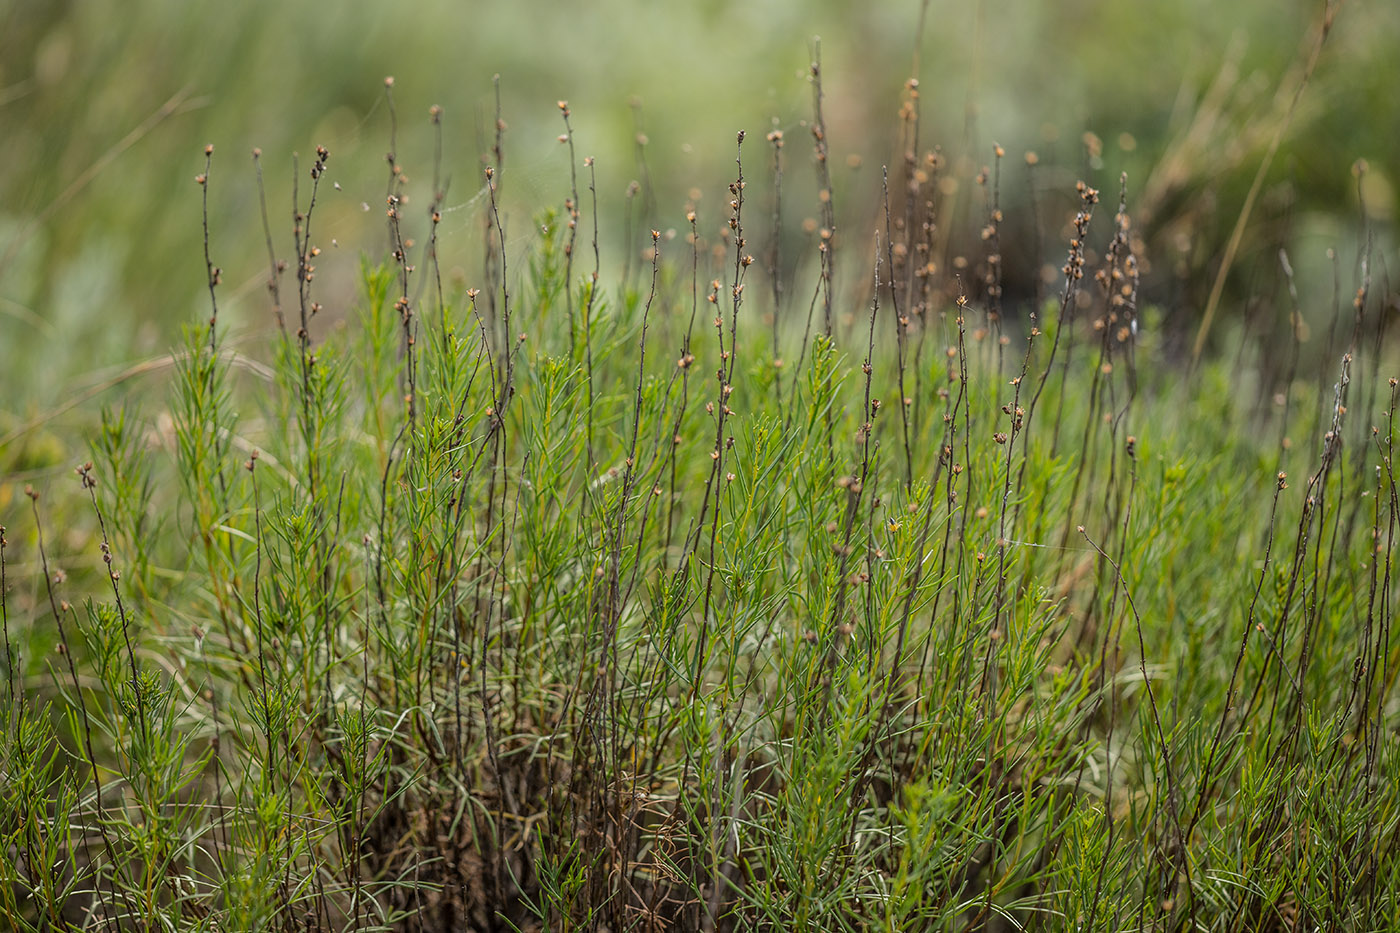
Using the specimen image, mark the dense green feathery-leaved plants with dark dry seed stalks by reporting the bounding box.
[0,30,1400,930]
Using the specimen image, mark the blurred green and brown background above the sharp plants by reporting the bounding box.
[0,0,1400,417]
